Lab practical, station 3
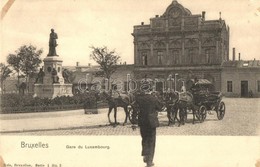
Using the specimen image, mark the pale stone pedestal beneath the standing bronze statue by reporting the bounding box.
[34,56,73,98]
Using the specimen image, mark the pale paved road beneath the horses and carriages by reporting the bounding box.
[2,98,260,136]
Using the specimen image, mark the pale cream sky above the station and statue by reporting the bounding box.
[0,0,260,66]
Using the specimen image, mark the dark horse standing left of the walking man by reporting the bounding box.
[100,91,134,126]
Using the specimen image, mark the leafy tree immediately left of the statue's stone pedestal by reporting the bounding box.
[7,45,43,93]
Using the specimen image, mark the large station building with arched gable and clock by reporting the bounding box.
[132,0,229,90]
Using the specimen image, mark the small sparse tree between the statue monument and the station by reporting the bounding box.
[90,46,120,89]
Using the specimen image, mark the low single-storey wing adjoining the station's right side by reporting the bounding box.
[221,60,260,97]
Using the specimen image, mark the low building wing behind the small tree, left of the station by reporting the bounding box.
[63,63,134,94]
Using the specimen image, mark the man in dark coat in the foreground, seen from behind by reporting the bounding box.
[136,87,162,167]
